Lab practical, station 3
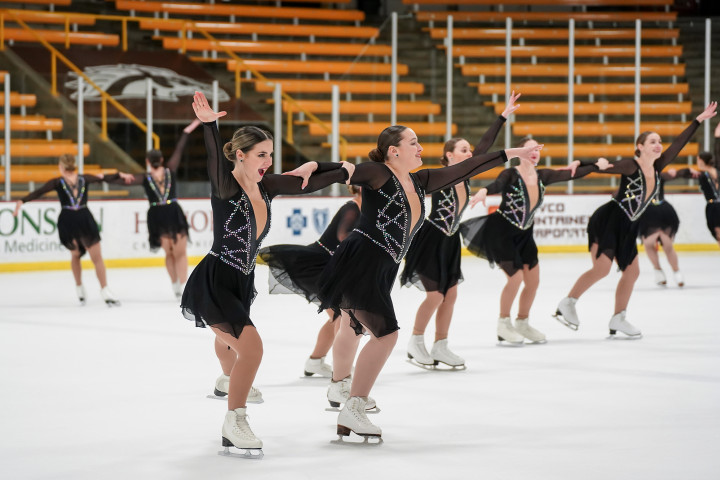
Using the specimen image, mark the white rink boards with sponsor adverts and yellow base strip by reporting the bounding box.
[0,194,717,271]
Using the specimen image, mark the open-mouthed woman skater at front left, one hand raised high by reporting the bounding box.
[181,92,352,456]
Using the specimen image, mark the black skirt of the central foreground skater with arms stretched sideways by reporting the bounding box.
[318,232,400,337]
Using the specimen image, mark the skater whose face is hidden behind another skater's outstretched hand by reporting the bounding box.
[460,137,610,346]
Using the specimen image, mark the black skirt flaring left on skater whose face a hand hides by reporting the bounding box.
[460,213,538,276]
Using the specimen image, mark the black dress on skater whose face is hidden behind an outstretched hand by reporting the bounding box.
[460,165,598,276]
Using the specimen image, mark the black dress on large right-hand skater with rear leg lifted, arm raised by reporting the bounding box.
[587,120,700,271]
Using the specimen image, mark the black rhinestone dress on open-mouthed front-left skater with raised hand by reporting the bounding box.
[180,122,347,337]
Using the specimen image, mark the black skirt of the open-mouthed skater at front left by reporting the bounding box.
[180,254,257,338]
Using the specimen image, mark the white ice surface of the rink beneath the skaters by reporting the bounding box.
[0,252,720,480]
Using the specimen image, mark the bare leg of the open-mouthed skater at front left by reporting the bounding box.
[213,325,263,410]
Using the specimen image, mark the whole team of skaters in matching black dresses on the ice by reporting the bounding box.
[16,92,720,458]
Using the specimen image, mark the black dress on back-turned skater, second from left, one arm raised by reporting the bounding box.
[123,132,190,251]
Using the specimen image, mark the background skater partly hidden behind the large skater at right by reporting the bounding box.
[638,168,697,287]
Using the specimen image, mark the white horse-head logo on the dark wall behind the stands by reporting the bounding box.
[65,63,230,102]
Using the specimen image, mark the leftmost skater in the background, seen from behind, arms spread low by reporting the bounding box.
[14,154,122,307]
